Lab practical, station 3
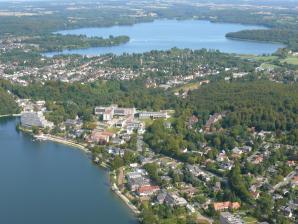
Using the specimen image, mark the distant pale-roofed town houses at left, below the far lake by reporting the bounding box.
[0,51,139,86]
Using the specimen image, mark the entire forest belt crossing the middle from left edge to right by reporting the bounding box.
[0,80,298,131]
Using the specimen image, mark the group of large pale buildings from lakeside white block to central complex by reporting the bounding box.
[17,99,170,145]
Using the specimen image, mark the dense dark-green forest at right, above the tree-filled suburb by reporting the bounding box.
[187,81,298,131]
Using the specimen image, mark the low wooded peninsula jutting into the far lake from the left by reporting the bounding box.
[23,34,129,51]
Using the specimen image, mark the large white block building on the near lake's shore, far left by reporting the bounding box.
[21,112,53,128]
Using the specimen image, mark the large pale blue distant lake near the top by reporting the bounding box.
[45,20,283,56]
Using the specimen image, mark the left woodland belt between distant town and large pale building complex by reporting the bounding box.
[0,80,170,123]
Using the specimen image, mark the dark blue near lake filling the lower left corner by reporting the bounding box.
[0,119,137,224]
